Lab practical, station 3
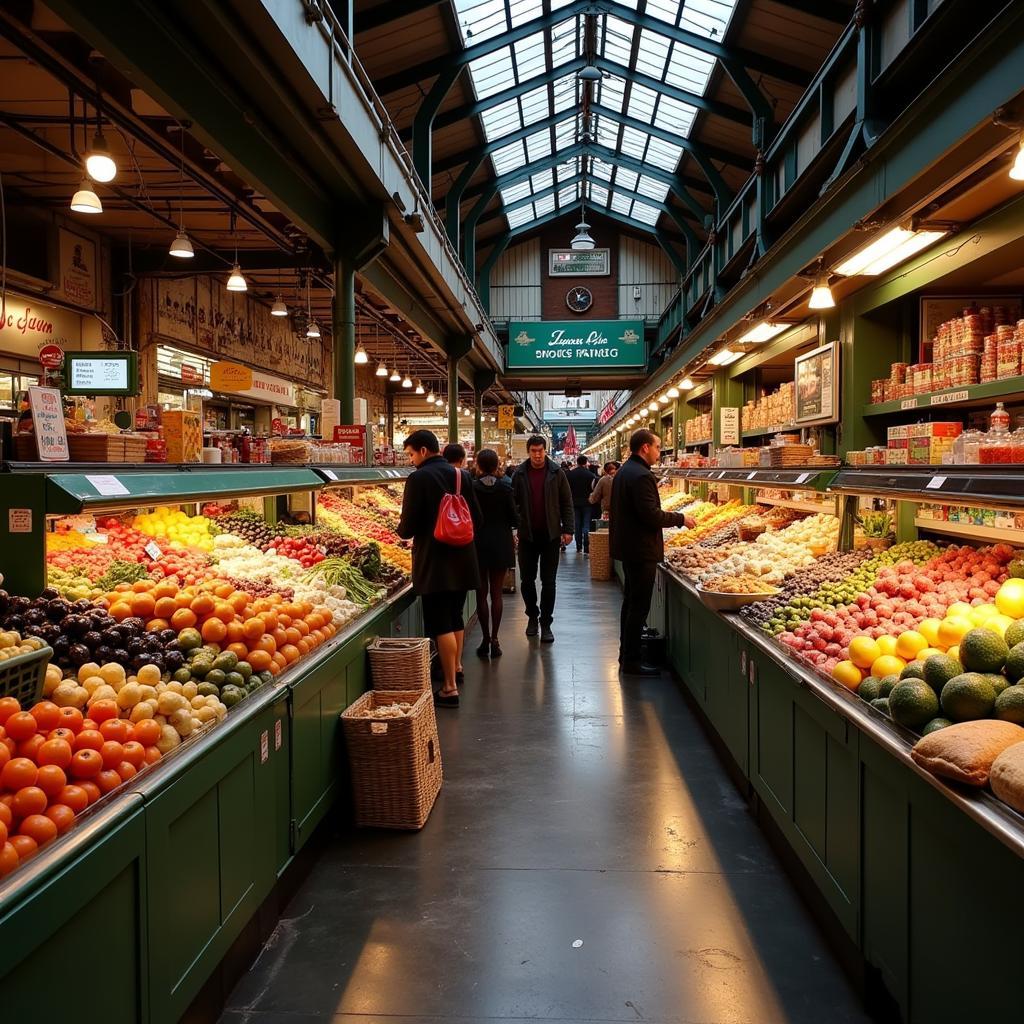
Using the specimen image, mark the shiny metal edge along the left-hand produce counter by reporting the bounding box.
[0,584,413,914]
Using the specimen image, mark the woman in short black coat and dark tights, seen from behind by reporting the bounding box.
[473,449,519,657]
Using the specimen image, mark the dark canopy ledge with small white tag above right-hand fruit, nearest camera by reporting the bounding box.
[830,466,1024,509]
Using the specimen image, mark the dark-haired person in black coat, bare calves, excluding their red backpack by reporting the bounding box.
[396,430,482,708]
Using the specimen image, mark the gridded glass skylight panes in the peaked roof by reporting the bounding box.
[454,0,736,228]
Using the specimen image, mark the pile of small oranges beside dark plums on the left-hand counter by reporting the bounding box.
[98,580,337,675]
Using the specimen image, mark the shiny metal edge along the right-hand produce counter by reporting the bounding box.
[662,564,1024,857]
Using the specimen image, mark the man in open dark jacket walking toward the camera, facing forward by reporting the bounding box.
[512,435,572,643]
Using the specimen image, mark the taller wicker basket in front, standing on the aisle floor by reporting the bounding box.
[341,690,441,829]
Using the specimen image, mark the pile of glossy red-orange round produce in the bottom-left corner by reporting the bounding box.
[0,697,161,878]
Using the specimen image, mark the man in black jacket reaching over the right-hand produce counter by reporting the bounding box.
[608,430,693,676]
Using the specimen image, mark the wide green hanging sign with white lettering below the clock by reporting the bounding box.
[506,321,647,371]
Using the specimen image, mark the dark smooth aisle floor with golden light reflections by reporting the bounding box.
[222,549,868,1024]
